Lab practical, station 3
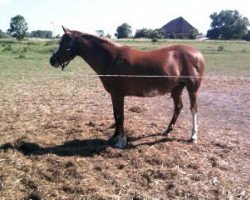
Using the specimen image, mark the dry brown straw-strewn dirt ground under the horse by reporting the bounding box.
[0,76,250,200]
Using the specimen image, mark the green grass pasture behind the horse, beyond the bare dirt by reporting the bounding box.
[0,39,250,85]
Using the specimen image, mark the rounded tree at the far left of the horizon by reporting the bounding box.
[8,15,28,41]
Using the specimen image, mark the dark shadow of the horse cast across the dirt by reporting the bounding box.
[0,133,188,157]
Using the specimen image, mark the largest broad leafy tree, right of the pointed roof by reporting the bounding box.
[207,10,249,40]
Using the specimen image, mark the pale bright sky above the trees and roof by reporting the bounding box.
[0,0,250,36]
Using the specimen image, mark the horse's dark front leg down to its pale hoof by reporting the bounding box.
[110,94,127,149]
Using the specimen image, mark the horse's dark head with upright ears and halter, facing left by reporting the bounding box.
[50,27,76,70]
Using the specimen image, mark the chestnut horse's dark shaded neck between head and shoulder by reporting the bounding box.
[78,37,116,74]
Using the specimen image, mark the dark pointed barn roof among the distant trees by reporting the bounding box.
[162,17,195,34]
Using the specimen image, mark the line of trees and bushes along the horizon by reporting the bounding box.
[0,10,250,41]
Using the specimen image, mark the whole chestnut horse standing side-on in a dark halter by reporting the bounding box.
[50,27,205,148]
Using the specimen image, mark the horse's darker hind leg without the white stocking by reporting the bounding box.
[163,83,185,135]
